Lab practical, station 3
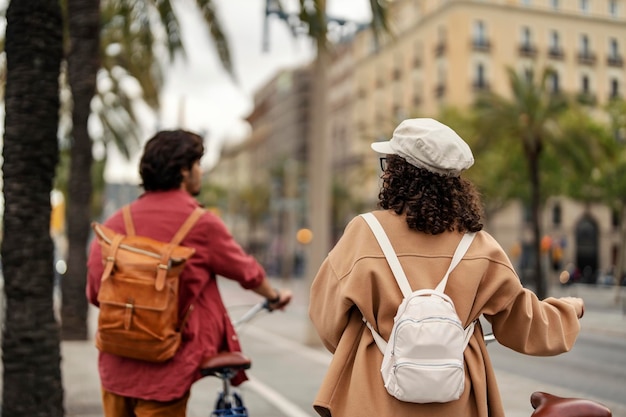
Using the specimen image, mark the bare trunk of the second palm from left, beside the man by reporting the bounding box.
[61,0,100,340]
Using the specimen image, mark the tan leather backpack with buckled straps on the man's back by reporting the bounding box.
[92,206,204,362]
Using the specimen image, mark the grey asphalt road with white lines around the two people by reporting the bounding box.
[179,282,626,417]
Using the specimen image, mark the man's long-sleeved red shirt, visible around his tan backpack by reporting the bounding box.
[87,190,265,401]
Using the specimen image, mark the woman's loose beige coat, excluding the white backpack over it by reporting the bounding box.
[309,211,580,417]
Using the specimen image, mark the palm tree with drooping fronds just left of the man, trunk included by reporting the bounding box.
[62,0,232,339]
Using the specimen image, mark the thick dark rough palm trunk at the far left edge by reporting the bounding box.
[2,0,64,417]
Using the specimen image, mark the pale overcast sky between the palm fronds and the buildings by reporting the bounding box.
[105,0,369,182]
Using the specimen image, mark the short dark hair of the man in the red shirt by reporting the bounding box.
[139,130,204,191]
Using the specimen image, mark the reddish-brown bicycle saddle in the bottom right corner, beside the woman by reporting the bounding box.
[530,391,612,417]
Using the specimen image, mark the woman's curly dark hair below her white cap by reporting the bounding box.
[378,155,483,235]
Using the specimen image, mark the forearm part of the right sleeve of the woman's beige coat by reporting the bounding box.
[485,288,580,356]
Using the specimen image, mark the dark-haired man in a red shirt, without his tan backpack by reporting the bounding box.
[87,130,291,417]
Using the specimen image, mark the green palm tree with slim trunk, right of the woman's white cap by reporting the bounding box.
[476,68,608,298]
